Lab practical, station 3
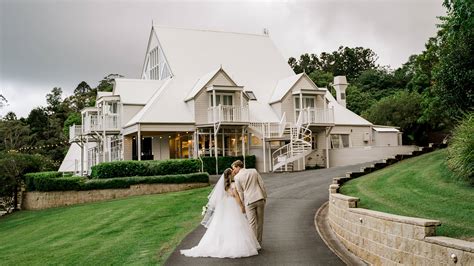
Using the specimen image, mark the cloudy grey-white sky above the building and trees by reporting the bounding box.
[0,0,445,116]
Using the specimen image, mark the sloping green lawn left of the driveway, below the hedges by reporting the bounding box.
[0,187,211,265]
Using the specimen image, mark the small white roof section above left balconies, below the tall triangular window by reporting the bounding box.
[113,78,165,105]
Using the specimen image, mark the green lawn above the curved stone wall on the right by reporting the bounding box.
[341,150,474,240]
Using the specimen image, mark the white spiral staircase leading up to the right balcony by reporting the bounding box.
[272,123,312,172]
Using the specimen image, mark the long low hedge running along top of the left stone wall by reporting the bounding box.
[28,173,209,191]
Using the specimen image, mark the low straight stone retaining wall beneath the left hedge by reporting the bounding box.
[22,183,209,210]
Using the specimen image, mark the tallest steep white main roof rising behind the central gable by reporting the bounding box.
[148,26,294,122]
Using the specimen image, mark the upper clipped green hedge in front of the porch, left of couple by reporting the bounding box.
[91,159,201,178]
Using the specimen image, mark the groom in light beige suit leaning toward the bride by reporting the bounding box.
[232,160,267,245]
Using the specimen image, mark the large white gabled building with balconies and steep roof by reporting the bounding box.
[60,26,413,175]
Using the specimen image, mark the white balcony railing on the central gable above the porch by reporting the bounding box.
[207,105,249,123]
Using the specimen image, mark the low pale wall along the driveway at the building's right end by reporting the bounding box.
[329,146,418,167]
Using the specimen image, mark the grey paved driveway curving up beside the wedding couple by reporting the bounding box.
[166,163,372,265]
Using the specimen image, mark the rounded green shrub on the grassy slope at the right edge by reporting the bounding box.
[447,112,474,184]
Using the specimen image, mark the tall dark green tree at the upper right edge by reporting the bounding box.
[432,0,474,122]
